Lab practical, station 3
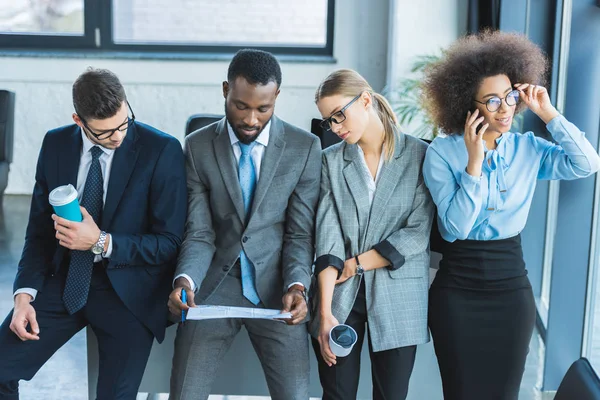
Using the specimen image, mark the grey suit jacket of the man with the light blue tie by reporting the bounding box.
[176,116,321,309]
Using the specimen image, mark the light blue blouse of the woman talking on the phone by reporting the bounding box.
[423,115,600,242]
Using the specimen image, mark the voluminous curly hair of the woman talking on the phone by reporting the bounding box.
[421,31,548,134]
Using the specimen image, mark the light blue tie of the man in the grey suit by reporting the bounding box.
[238,142,260,305]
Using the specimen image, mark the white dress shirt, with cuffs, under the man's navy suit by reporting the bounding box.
[14,130,115,300]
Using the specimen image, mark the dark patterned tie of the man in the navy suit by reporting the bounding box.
[63,146,104,314]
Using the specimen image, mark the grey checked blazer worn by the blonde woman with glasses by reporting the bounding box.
[309,134,434,351]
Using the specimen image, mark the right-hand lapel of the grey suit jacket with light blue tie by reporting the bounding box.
[250,116,285,217]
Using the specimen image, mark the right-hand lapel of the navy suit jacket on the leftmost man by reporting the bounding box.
[101,123,139,229]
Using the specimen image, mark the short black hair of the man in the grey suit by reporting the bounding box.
[227,49,281,87]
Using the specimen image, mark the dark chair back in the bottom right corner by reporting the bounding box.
[554,357,600,400]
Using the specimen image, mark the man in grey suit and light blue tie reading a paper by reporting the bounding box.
[169,50,321,400]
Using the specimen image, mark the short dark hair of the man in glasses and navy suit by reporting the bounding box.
[73,67,127,120]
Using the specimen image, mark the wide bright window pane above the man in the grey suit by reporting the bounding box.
[113,0,327,46]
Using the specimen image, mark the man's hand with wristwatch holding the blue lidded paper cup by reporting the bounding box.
[52,207,100,251]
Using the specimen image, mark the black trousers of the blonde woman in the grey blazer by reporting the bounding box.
[312,280,417,400]
